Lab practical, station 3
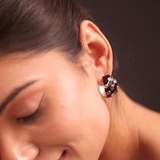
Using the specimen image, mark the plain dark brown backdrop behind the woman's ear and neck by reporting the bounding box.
[82,0,160,112]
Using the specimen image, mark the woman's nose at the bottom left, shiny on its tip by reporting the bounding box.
[0,136,39,160]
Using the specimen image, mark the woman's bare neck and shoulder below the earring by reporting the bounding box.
[99,90,160,160]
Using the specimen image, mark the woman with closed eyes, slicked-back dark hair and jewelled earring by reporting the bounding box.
[0,0,160,160]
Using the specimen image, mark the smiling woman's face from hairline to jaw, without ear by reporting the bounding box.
[0,53,110,160]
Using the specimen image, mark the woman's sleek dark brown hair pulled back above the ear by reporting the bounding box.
[0,0,91,60]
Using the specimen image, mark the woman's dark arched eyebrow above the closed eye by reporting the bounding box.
[0,80,37,115]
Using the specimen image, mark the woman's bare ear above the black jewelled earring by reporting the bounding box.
[79,20,113,83]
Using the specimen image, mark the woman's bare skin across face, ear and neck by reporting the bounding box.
[0,21,160,160]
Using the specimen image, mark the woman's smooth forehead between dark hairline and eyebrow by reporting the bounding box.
[0,53,77,101]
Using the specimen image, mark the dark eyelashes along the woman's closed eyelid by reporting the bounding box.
[17,96,44,123]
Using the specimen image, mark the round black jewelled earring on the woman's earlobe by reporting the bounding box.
[99,75,119,98]
